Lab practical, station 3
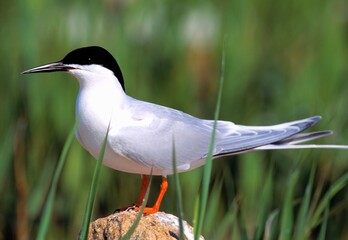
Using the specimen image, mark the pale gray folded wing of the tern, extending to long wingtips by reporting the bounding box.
[108,97,328,171]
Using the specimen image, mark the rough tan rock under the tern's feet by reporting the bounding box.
[88,210,204,240]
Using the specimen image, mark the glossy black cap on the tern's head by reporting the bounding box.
[61,46,125,90]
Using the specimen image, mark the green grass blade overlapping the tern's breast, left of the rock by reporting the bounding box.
[80,123,110,239]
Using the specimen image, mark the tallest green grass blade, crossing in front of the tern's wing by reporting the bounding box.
[195,36,225,239]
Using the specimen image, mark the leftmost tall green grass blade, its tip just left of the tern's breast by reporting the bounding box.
[36,125,76,240]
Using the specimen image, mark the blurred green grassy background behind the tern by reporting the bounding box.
[0,0,348,239]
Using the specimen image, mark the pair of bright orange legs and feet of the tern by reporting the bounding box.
[135,175,168,215]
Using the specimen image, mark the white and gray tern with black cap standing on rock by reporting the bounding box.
[22,46,348,214]
